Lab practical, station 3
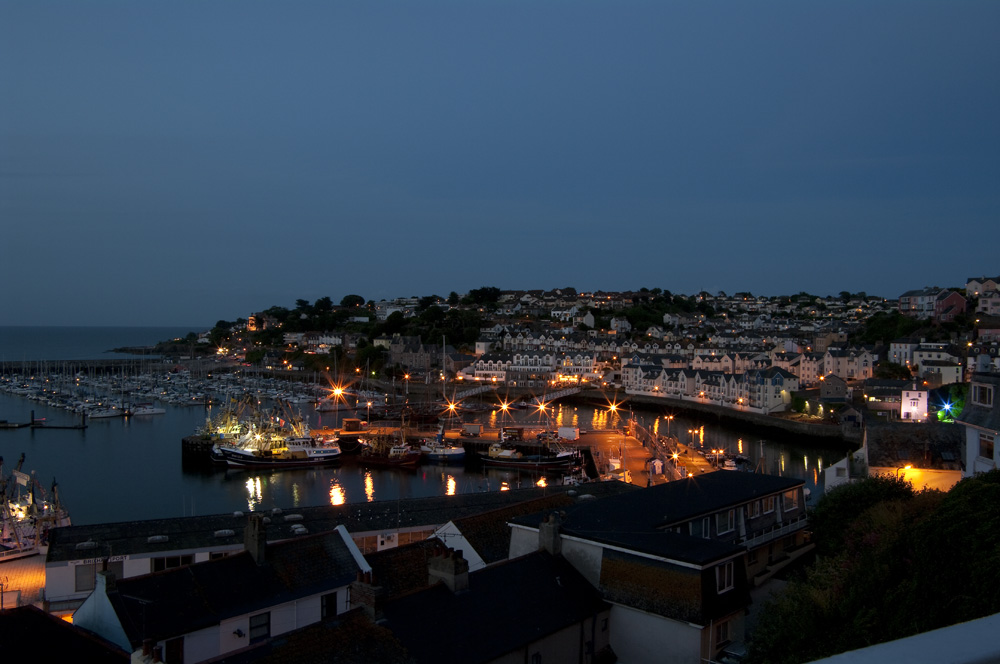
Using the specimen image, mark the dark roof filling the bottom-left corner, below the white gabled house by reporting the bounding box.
[0,606,130,663]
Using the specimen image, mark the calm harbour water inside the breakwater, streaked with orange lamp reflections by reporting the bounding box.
[0,393,844,524]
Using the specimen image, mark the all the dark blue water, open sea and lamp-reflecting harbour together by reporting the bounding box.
[0,327,846,524]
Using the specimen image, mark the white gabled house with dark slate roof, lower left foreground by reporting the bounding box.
[73,514,371,664]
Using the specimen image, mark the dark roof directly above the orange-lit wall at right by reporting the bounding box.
[865,423,965,470]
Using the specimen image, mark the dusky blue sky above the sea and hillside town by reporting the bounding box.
[0,0,1000,327]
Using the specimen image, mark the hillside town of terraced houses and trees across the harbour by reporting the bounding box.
[188,277,1000,422]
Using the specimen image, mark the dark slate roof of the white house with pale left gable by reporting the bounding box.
[108,532,360,648]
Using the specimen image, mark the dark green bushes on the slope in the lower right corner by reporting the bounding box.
[748,471,1000,664]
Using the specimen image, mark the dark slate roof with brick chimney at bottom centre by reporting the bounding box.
[381,551,610,664]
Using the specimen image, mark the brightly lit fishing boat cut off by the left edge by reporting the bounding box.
[0,454,70,563]
